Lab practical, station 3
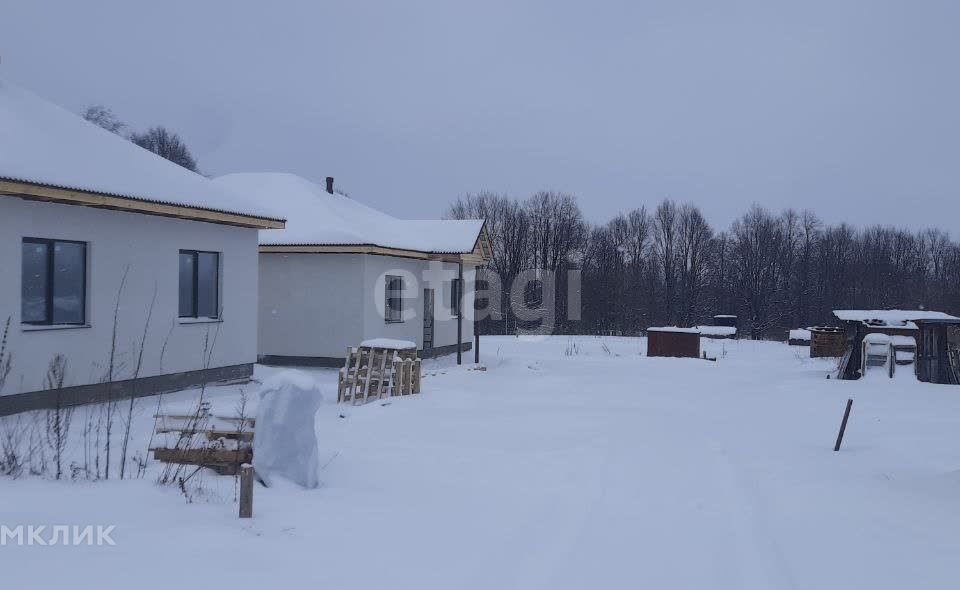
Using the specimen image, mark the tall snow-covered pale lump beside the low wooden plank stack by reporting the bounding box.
[253,369,323,488]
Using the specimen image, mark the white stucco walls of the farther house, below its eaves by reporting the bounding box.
[259,254,475,358]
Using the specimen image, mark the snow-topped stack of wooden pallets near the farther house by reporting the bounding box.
[337,345,420,404]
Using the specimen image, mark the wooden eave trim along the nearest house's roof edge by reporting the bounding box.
[0,178,286,229]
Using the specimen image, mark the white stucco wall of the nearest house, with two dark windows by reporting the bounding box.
[0,195,257,394]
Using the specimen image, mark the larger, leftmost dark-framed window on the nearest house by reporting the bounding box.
[20,238,87,326]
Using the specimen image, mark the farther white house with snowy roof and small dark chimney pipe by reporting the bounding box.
[214,173,490,366]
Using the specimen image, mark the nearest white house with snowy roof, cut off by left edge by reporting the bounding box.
[0,80,284,414]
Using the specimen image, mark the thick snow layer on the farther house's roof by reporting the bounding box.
[214,172,483,254]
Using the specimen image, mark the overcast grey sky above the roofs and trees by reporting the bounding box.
[0,0,960,235]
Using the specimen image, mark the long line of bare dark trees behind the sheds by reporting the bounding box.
[447,192,960,338]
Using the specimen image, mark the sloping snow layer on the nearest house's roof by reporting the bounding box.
[0,79,283,220]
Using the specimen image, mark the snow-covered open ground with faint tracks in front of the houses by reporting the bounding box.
[0,337,960,590]
